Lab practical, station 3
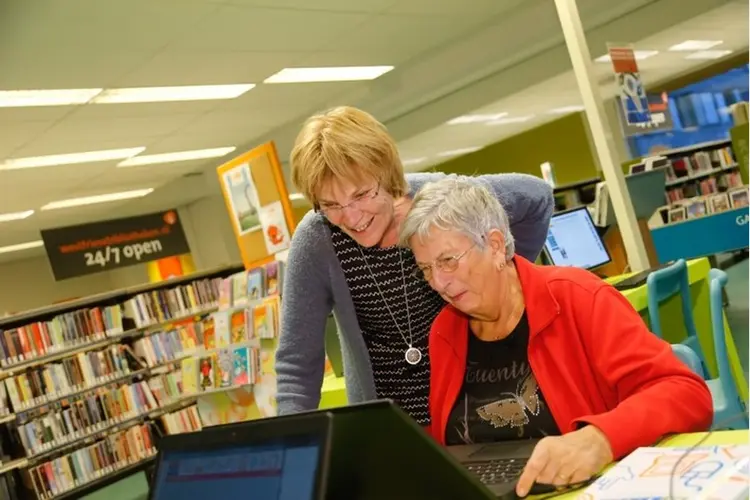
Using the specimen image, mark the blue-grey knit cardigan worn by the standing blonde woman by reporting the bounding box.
[276,173,554,415]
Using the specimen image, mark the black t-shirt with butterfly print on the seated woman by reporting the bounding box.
[446,312,560,445]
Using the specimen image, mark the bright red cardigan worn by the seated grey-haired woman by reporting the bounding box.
[429,256,713,459]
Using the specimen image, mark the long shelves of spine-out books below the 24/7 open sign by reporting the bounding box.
[0,266,243,500]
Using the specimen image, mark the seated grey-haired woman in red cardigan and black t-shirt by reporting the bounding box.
[400,179,713,496]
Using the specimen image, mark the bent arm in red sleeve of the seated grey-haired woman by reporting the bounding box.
[577,286,713,459]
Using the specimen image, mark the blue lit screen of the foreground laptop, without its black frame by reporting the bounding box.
[152,438,320,500]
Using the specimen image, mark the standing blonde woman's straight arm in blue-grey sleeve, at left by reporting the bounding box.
[276,212,333,415]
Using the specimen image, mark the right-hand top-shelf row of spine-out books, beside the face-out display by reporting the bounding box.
[123,278,222,328]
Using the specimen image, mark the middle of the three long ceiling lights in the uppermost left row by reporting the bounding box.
[91,83,255,104]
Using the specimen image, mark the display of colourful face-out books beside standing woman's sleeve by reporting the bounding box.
[175,261,283,432]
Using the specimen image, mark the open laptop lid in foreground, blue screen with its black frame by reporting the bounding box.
[149,412,332,500]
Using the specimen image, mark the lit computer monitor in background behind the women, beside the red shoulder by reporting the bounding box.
[544,207,612,269]
